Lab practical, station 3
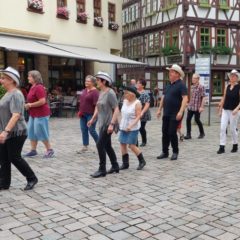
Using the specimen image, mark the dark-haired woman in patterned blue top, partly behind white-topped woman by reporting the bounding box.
[137,79,151,147]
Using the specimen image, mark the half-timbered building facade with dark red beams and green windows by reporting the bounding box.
[118,0,240,100]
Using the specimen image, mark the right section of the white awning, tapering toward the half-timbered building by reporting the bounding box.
[41,42,146,65]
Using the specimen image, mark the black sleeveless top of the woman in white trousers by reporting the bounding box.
[223,84,240,110]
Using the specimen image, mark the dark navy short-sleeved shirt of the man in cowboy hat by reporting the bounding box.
[163,79,187,116]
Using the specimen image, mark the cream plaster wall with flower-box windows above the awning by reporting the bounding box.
[0,0,122,52]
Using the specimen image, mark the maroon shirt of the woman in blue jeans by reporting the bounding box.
[79,88,99,114]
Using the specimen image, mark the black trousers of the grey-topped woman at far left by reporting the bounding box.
[0,136,35,188]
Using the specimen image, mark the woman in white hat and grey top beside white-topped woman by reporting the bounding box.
[88,72,119,178]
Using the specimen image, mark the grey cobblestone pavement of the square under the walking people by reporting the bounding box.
[0,109,240,240]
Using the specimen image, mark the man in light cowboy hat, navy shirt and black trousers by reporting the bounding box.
[157,64,188,160]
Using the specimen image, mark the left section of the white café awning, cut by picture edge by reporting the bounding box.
[0,36,87,59]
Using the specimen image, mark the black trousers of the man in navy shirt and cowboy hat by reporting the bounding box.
[162,116,179,154]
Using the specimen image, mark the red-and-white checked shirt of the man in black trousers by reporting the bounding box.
[188,84,205,111]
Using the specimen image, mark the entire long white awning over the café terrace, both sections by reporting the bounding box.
[0,35,146,65]
